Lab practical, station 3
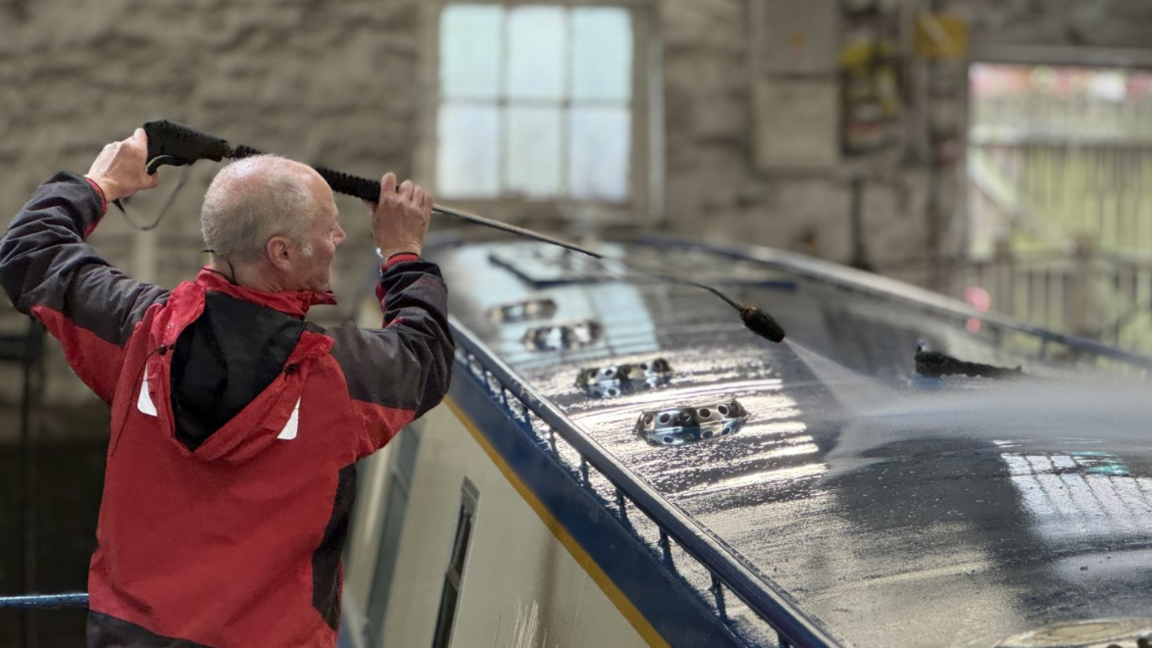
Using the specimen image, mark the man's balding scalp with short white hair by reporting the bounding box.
[200,156,319,263]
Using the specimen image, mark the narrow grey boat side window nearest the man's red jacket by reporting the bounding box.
[367,425,419,646]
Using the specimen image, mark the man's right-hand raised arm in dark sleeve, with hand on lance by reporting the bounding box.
[328,173,455,457]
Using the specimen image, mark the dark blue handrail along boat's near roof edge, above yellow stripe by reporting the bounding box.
[449,315,841,648]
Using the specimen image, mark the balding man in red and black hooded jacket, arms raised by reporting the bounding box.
[0,130,453,648]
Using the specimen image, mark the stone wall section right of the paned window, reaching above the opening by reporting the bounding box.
[659,0,1152,276]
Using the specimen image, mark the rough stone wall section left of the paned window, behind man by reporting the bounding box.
[0,0,424,401]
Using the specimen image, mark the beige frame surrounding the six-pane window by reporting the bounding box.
[415,0,664,226]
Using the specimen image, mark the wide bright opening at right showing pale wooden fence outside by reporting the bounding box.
[954,57,1152,353]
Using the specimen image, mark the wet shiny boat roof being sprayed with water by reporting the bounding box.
[431,237,1152,647]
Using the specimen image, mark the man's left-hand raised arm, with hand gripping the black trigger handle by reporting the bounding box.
[0,129,167,402]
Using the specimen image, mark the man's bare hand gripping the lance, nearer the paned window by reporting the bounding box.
[369,173,432,259]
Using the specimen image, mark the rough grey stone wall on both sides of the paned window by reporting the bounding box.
[0,0,1152,401]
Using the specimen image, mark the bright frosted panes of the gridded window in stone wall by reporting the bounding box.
[435,3,647,206]
